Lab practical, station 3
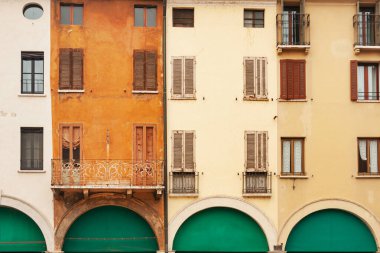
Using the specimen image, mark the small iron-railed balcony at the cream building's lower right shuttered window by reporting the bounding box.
[243,171,272,197]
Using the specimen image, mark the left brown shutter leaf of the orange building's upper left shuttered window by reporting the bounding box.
[59,48,71,89]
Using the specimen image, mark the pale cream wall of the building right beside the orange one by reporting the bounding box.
[167,1,277,241]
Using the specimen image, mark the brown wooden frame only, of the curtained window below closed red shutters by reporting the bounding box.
[281,137,306,176]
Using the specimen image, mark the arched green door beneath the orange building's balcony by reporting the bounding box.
[63,206,158,252]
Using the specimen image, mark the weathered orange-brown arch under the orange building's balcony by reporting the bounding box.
[55,194,165,251]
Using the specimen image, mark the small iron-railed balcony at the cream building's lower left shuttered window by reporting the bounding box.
[169,171,199,196]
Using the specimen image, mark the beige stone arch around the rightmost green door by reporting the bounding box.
[278,199,380,249]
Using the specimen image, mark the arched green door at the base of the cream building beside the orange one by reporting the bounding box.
[173,207,268,253]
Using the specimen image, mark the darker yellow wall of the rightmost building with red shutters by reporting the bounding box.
[276,1,380,245]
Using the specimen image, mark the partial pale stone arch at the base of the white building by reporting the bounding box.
[0,195,54,252]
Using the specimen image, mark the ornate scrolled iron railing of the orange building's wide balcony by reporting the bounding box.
[52,159,164,188]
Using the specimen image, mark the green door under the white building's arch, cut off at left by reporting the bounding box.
[0,207,46,252]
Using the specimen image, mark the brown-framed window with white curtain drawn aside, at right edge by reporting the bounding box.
[358,138,380,175]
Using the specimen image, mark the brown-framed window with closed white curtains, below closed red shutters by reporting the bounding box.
[281,138,305,175]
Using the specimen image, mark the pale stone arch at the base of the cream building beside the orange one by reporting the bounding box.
[168,197,277,251]
